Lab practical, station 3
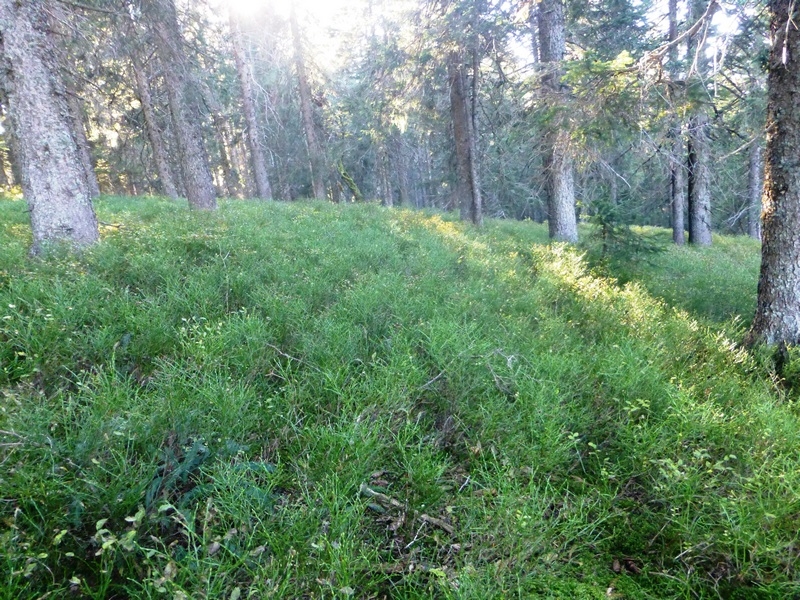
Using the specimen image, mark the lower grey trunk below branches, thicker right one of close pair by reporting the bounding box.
[688,112,711,246]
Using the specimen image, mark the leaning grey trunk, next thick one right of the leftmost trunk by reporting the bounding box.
[142,0,217,210]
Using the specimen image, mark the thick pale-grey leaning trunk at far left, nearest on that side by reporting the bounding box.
[0,0,99,254]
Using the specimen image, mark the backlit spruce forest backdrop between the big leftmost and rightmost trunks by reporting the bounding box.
[0,0,769,239]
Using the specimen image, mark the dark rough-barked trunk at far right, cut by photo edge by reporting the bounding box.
[747,0,800,345]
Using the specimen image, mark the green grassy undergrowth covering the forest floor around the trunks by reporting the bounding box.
[0,198,800,600]
